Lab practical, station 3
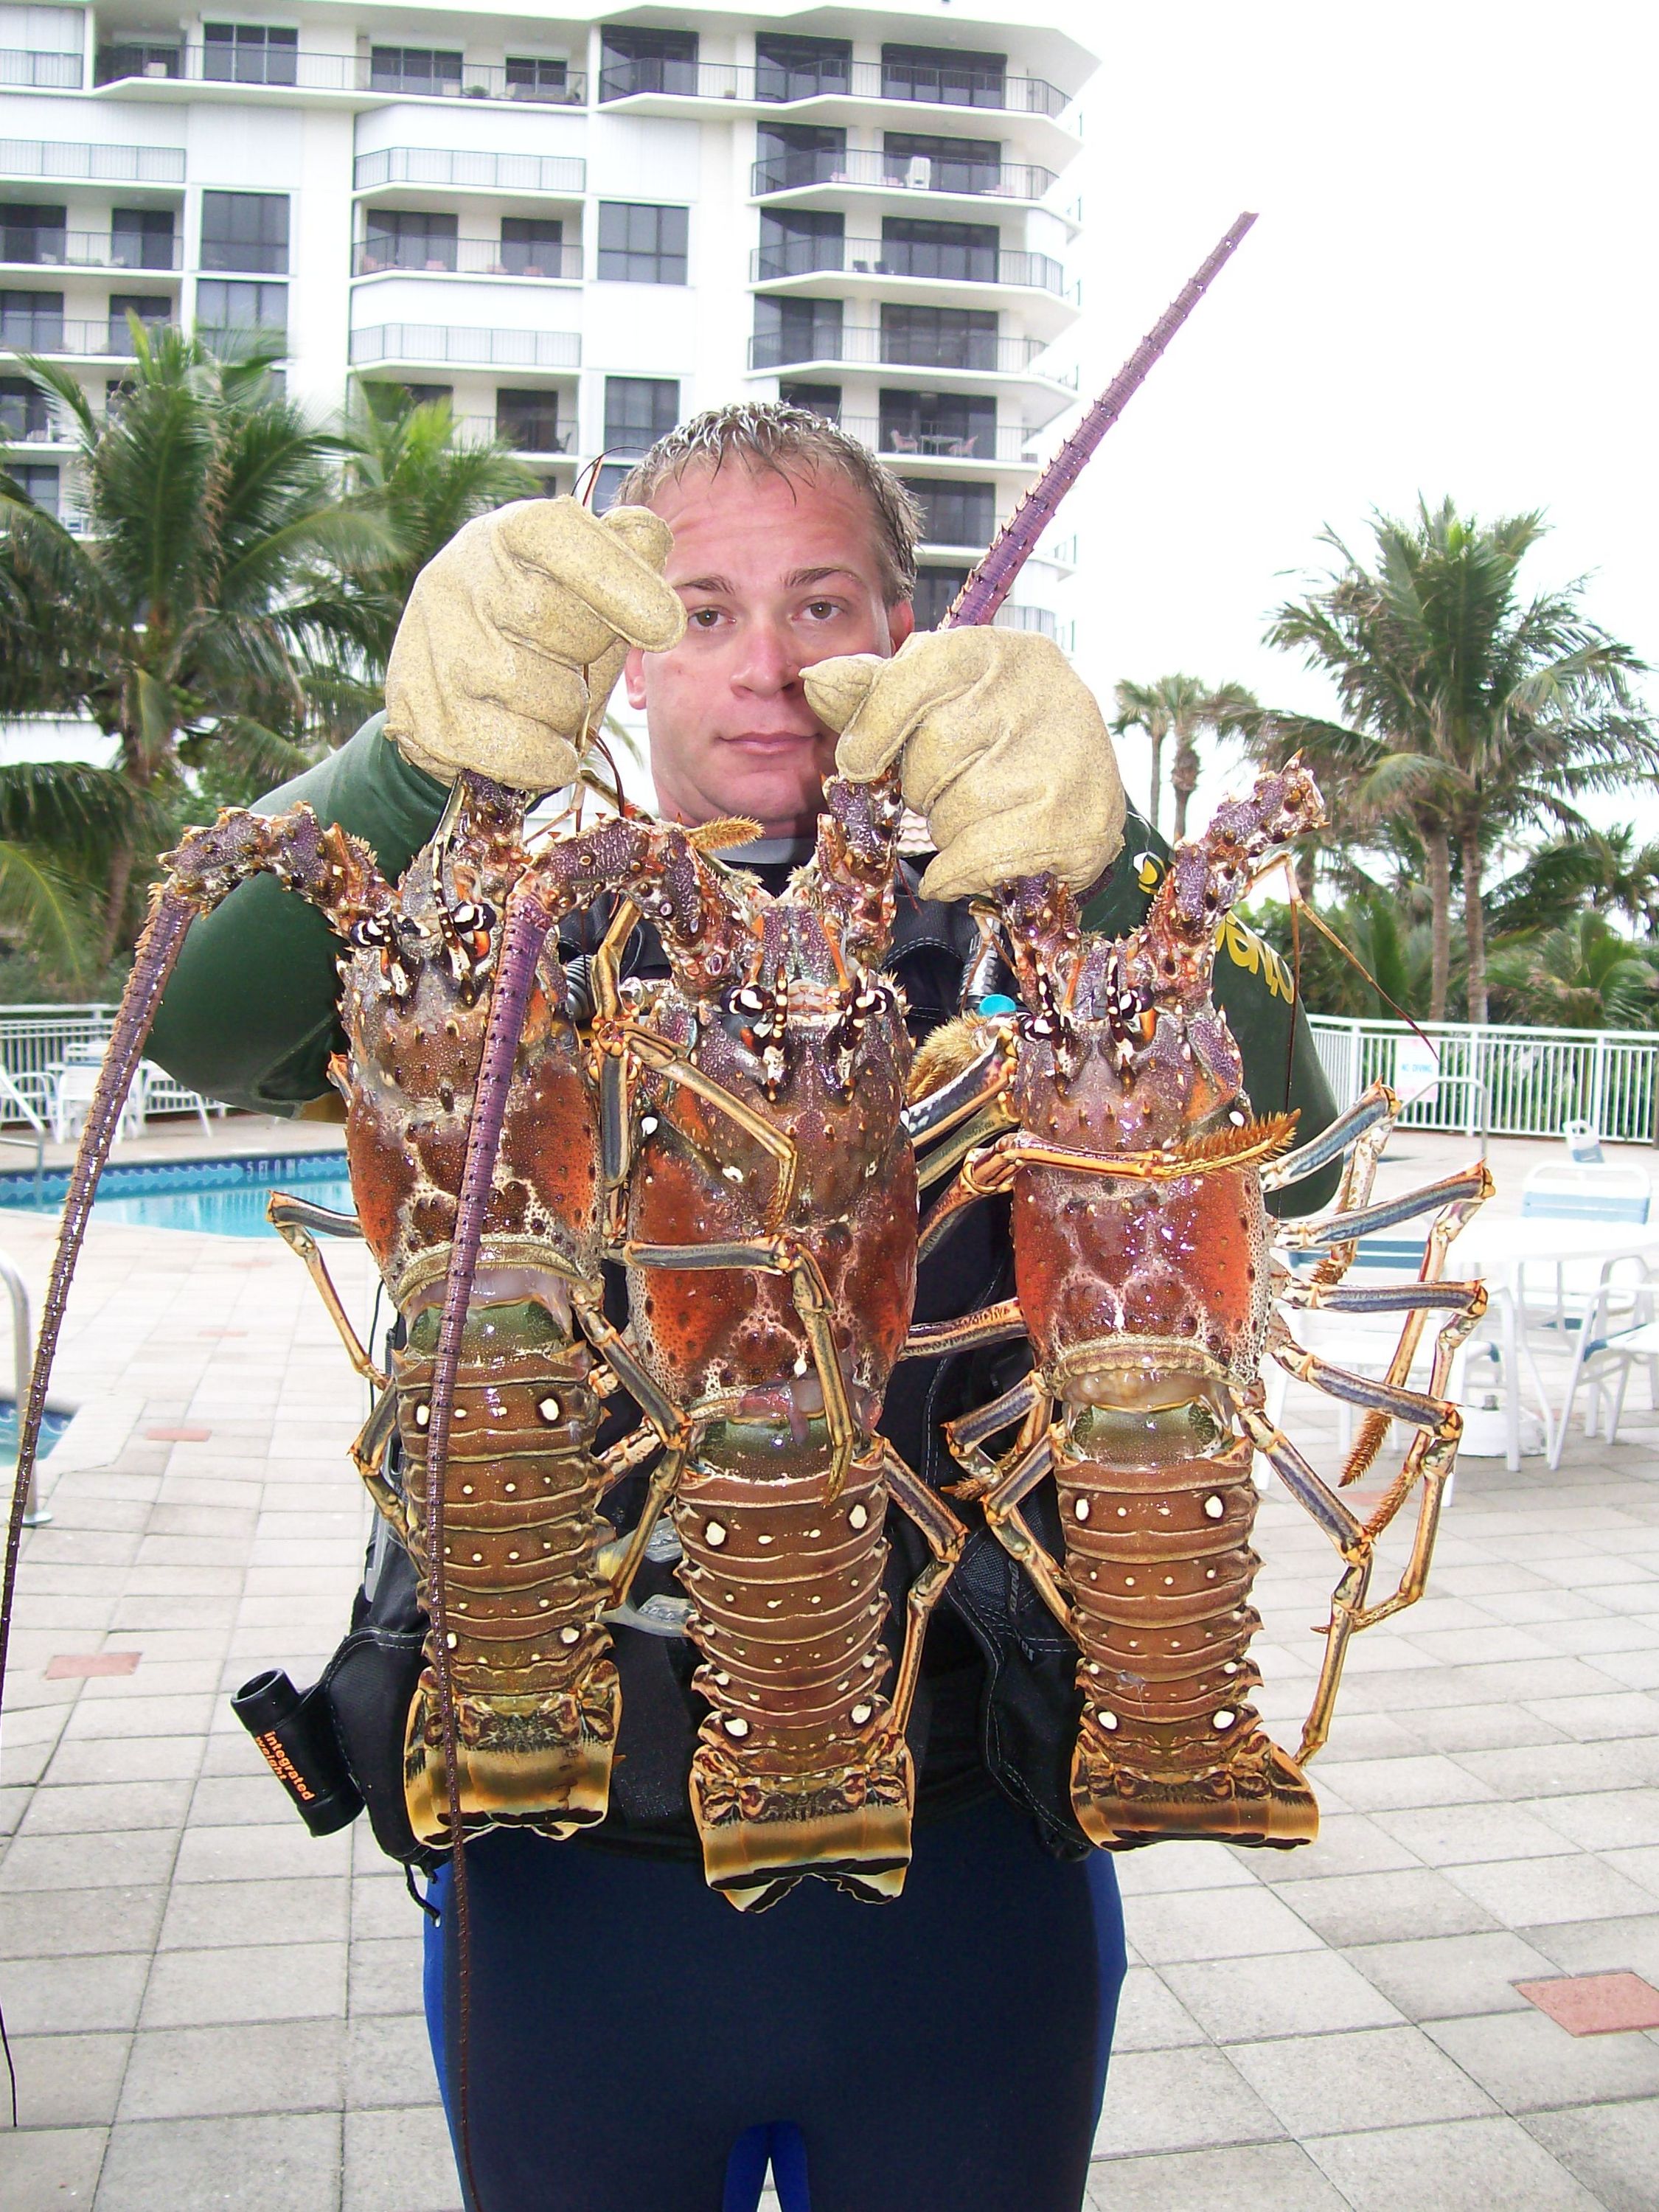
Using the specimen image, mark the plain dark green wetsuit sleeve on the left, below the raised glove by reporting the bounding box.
[148,714,447,1115]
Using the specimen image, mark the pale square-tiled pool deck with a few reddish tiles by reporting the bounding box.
[0,1121,1659,2212]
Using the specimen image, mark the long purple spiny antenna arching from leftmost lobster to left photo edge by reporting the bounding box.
[0,805,385,1690]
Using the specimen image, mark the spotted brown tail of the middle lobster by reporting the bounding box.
[675,1449,916,1911]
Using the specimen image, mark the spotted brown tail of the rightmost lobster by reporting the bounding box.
[1055,1416,1318,1849]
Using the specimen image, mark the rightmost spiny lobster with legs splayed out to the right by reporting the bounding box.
[909,765,1491,1847]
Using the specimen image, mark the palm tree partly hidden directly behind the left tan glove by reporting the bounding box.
[299,385,542,737]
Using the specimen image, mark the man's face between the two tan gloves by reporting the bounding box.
[626,462,914,836]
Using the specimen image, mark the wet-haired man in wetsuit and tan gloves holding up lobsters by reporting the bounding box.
[153,407,1329,2212]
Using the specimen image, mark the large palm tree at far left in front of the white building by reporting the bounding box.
[0,319,385,964]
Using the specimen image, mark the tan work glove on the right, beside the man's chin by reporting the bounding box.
[801,628,1124,898]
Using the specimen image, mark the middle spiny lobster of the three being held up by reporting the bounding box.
[429,779,964,1907]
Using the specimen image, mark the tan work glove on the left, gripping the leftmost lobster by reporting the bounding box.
[385,500,686,792]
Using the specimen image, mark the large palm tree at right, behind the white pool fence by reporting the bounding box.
[1259,500,1659,1022]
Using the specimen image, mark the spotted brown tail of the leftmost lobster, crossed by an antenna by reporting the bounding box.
[396,1301,622,1847]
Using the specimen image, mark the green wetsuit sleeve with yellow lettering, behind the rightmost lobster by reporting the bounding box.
[1084,814,1343,1217]
